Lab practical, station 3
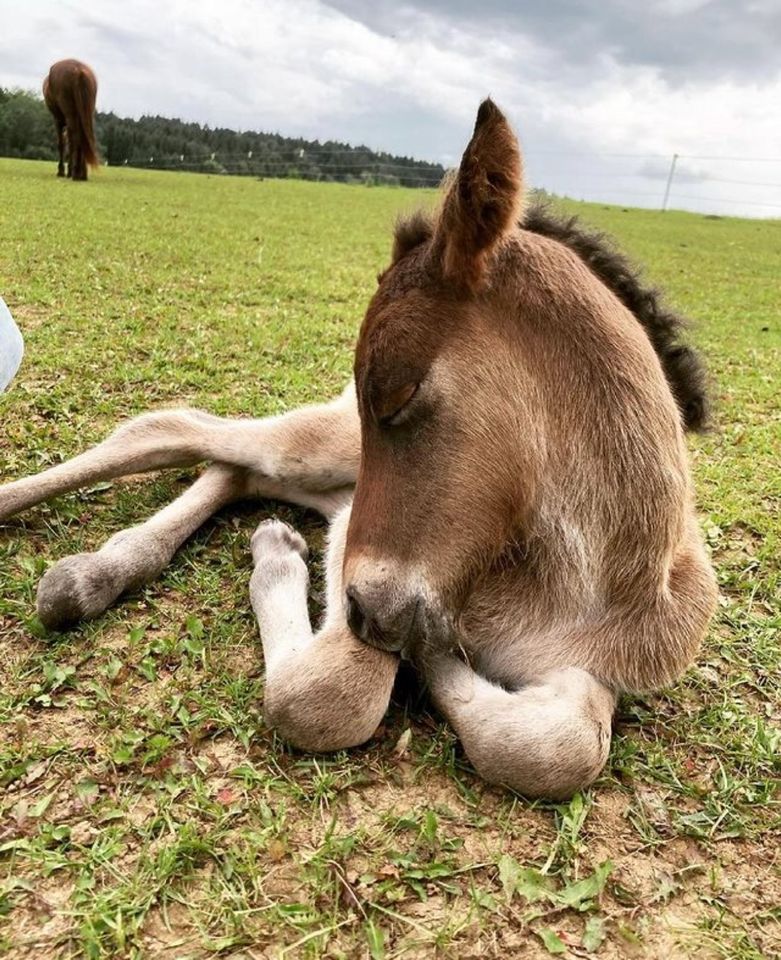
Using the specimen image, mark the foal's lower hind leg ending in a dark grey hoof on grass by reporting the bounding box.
[38,464,247,629]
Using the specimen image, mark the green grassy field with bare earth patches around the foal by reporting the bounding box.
[0,160,781,960]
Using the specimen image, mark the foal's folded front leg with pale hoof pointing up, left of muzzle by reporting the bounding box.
[250,509,398,750]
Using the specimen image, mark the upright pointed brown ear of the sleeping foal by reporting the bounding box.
[434,99,523,293]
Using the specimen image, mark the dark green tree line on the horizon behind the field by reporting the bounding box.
[0,87,445,187]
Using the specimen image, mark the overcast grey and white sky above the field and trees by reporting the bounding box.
[0,0,781,216]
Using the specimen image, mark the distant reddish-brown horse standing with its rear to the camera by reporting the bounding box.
[43,60,99,180]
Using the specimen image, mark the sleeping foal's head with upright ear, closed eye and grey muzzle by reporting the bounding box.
[344,100,534,649]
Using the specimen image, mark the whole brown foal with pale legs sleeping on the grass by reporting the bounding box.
[0,101,716,798]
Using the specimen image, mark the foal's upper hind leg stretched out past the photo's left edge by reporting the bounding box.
[0,388,360,520]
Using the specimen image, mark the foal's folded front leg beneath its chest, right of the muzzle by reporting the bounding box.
[427,654,616,800]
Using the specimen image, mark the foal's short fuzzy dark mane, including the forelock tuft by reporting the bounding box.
[393,203,710,430]
